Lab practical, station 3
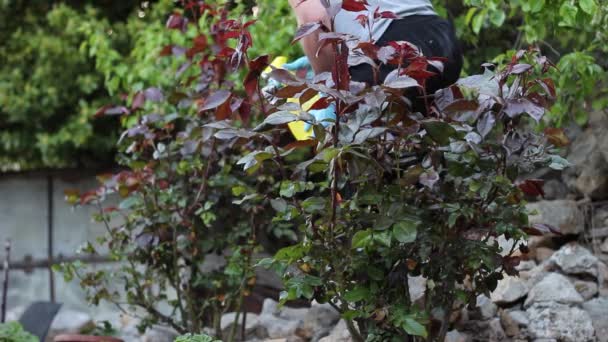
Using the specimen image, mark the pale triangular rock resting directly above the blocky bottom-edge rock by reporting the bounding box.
[524,273,583,308]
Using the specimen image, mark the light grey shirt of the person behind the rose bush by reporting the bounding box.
[332,0,436,41]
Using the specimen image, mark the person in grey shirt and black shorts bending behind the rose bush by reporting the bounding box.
[285,0,463,117]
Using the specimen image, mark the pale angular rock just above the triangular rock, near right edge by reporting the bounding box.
[549,242,599,277]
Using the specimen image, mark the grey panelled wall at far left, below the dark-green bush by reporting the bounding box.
[0,172,115,312]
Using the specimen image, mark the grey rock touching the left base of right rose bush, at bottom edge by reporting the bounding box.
[296,301,340,341]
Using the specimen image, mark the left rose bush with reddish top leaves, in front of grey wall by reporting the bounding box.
[58,1,282,340]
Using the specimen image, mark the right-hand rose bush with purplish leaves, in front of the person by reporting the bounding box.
[216,1,567,341]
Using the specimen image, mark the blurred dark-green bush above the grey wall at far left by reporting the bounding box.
[0,1,151,170]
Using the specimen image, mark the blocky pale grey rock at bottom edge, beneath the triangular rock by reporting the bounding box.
[527,303,595,342]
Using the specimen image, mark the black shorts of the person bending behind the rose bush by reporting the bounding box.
[350,15,462,108]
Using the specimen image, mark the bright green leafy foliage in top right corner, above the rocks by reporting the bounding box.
[435,0,608,125]
